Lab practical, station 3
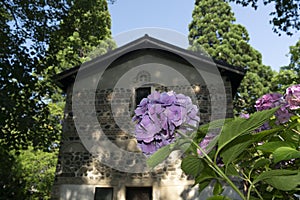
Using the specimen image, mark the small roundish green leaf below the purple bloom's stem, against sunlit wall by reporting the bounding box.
[181,155,204,177]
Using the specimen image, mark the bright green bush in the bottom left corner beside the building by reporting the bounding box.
[0,148,58,200]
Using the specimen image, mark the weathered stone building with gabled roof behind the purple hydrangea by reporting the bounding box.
[52,35,244,200]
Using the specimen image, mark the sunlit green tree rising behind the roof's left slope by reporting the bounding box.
[47,0,115,73]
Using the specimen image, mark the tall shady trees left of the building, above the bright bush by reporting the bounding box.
[0,0,113,150]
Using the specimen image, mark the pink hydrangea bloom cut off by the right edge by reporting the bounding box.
[285,84,300,110]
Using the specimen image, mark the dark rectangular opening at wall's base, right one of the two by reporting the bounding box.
[126,187,152,200]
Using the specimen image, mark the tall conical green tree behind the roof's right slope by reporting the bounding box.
[189,0,273,113]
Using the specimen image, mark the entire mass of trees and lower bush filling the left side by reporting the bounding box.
[0,0,114,199]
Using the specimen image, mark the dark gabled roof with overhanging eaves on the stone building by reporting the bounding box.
[55,34,246,94]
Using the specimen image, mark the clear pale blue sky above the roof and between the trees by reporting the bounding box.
[109,0,300,70]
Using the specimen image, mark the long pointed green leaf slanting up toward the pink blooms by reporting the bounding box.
[217,108,278,155]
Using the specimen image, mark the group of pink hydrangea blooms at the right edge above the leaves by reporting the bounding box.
[255,84,300,124]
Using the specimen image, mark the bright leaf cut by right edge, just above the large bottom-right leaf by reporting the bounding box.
[273,147,300,163]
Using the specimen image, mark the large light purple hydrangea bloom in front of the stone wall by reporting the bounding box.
[132,91,200,155]
